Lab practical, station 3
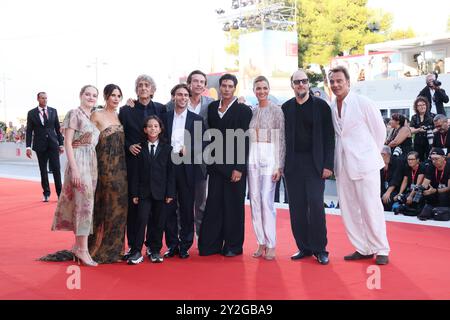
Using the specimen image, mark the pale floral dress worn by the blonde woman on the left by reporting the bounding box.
[52,108,99,236]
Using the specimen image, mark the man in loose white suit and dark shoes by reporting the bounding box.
[329,66,390,265]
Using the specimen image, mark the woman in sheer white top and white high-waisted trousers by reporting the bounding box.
[248,76,285,260]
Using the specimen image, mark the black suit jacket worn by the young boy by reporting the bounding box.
[130,140,175,200]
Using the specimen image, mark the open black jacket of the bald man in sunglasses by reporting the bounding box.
[281,96,335,175]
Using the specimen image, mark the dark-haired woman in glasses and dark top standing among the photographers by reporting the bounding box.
[410,96,435,162]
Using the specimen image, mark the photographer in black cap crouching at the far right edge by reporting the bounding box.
[417,148,450,220]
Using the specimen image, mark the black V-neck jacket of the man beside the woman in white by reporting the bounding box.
[208,100,253,178]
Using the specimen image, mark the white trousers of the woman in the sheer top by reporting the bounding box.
[248,142,276,248]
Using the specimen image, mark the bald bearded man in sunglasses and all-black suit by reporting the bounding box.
[281,70,334,264]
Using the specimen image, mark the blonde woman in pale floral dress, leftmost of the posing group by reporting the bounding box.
[52,85,99,266]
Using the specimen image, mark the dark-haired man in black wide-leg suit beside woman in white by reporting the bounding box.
[198,74,252,257]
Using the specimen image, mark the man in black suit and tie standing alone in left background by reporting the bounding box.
[26,92,64,202]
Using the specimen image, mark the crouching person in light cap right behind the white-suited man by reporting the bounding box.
[380,146,402,211]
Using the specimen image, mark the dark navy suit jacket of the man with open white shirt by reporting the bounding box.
[163,110,206,187]
